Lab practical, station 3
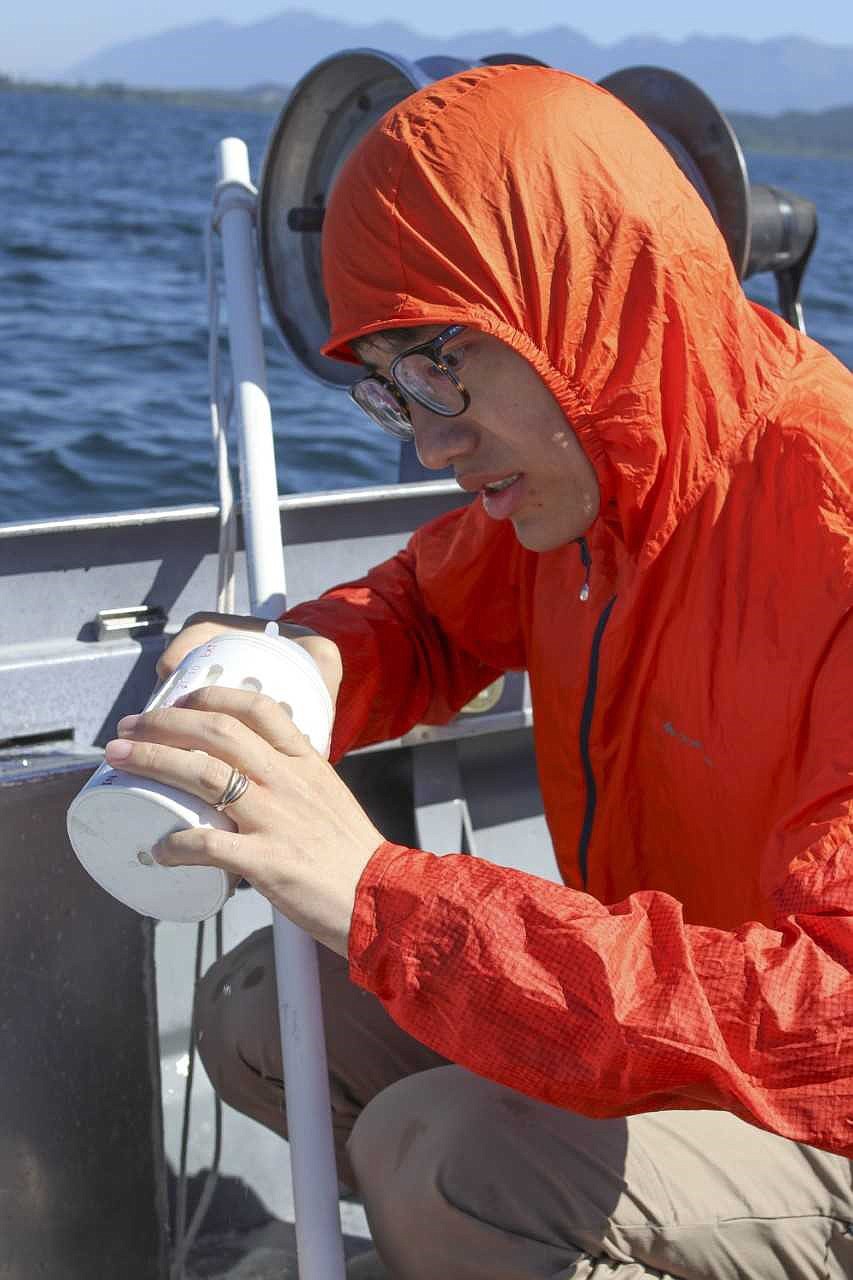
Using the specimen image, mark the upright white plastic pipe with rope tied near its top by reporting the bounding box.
[214,138,345,1280]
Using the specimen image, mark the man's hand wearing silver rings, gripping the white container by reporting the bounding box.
[106,685,384,955]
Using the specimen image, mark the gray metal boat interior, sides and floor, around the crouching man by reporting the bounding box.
[0,481,556,1280]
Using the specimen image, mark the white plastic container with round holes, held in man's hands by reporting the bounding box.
[68,622,333,922]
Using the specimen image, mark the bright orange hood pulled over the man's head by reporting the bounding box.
[323,67,795,557]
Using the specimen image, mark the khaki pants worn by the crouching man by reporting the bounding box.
[197,929,853,1280]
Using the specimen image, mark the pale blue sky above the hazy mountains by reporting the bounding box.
[0,0,853,76]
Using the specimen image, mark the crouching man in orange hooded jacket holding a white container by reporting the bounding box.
[108,68,853,1280]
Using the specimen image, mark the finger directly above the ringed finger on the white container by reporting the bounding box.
[117,706,275,782]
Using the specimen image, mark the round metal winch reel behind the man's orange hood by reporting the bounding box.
[259,49,817,387]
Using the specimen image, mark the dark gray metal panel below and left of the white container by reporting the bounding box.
[0,759,167,1280]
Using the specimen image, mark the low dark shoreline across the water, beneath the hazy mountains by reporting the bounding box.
[6,76,853,160]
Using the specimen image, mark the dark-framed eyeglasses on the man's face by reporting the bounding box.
[350,324,471,440]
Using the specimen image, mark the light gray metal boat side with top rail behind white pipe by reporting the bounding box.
[0,481,467,746]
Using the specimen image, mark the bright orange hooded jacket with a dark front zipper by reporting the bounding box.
[289,67,853,1155]
